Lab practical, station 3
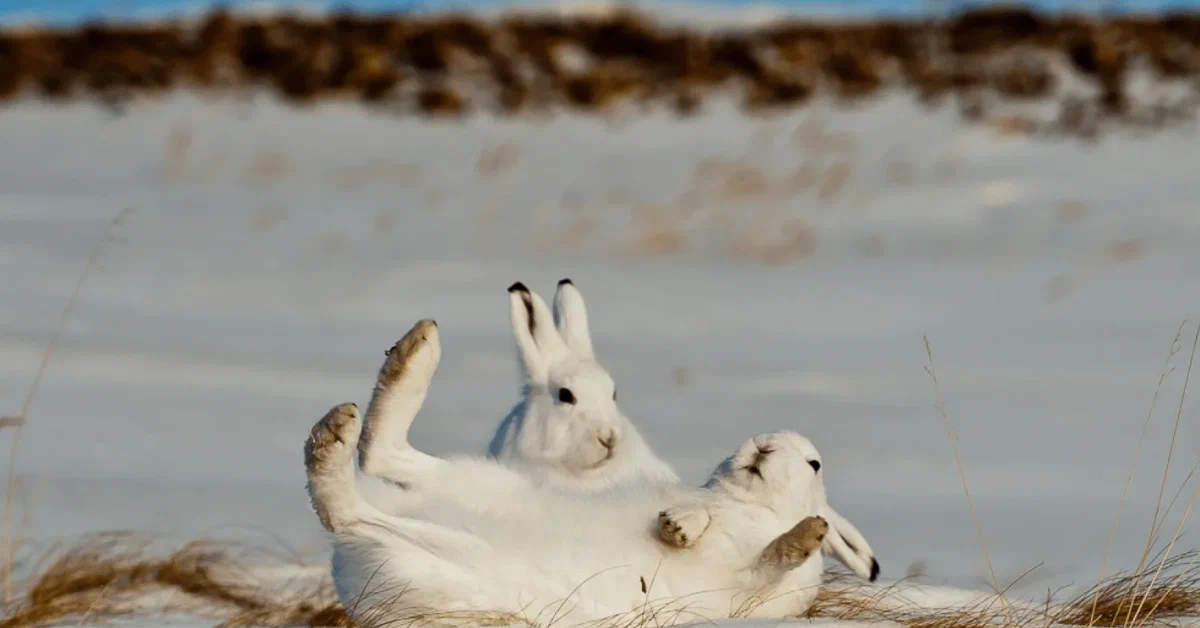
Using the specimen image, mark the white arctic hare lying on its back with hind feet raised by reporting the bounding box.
[305,321,868,623]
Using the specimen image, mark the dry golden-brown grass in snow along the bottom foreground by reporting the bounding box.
[7,532,1200,628]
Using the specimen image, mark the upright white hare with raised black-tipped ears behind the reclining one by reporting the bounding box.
[487,279,679,489]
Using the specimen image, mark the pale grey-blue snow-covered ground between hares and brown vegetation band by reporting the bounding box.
[0,82,1200,619]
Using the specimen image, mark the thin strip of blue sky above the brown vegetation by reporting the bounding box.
[7,0,1200,23]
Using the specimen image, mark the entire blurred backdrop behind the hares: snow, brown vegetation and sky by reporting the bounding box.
[0,0,1200,619]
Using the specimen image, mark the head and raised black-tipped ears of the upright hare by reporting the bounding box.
[494,279,636,477]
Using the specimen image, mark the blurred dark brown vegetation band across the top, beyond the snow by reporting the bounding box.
[0,6,1200,133]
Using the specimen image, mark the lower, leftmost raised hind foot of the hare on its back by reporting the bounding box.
[304,403,362,532]
